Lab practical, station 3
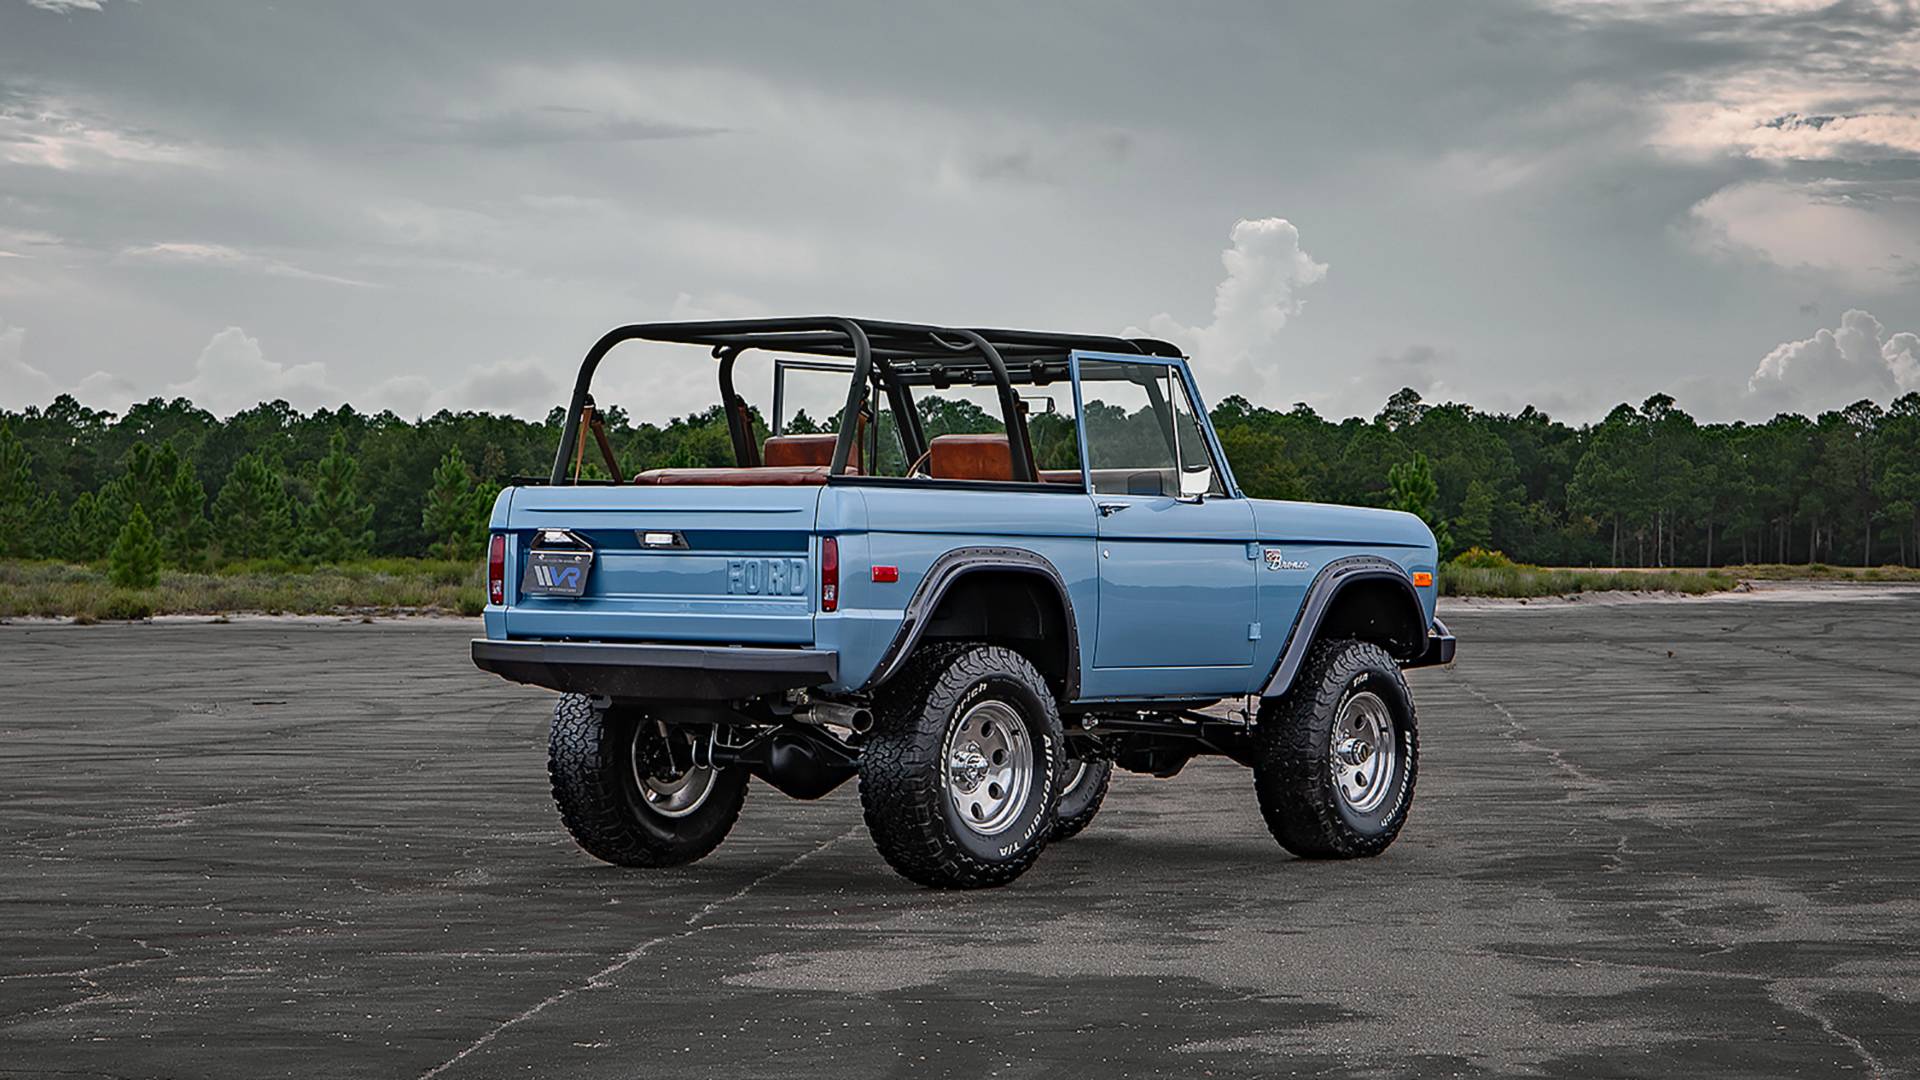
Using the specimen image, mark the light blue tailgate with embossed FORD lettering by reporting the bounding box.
[505,486,822,646]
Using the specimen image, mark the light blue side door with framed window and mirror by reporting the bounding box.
[1075,354,1260,672]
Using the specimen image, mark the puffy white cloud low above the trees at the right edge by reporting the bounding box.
[1747,307,1920,411]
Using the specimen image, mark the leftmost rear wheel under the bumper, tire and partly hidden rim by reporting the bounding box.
[547,694,747,867]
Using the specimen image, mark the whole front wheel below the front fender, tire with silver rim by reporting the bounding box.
[1254,640,1419,859]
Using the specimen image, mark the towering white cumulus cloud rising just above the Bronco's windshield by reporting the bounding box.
[1127,217,1327,390]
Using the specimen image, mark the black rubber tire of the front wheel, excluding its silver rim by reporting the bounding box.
[1254,640,1419,859]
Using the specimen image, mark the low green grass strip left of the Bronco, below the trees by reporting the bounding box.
[0,559,486,623]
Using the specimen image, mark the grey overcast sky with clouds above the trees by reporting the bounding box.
[0,0,1920,423]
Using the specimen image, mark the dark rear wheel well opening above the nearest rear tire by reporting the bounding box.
[920,569,1079,696]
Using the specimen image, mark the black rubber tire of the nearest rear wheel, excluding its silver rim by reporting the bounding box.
[860,644,1066,888]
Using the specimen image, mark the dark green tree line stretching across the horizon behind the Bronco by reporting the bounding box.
[0,390,1920,582]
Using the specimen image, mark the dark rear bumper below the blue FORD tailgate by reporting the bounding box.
[472,638,839,701]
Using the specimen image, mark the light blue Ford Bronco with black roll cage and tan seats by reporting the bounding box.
[472,317,1453,888]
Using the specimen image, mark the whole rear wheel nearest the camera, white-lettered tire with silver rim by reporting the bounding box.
[860,646,1066,888]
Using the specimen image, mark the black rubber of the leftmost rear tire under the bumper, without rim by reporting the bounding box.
[547,694,747,867]
